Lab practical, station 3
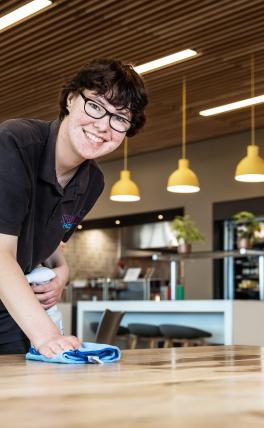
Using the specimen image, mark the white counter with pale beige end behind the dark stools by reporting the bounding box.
[77,300,264,346]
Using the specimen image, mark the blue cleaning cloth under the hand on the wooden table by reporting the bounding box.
[26,342,121,364]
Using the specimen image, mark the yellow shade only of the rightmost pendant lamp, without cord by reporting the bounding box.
[235,145,264,183]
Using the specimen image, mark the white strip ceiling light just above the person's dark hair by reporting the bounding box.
[134,49,198,74]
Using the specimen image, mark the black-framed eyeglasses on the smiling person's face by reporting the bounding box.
[80,92,132,132]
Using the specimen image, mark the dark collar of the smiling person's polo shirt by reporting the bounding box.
[38,119,93,201]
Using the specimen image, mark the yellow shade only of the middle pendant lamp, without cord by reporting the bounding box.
[167,159,200,193]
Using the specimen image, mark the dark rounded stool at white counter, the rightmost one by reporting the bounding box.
[160,324,212,348]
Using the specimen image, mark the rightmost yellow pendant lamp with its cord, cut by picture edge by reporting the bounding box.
[235,55,264,183]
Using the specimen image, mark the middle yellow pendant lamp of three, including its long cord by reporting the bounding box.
[167,79,200,193]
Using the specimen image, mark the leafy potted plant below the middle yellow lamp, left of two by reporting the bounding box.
[171,215,205,253]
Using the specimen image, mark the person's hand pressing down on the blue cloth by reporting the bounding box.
[33,334,81,358]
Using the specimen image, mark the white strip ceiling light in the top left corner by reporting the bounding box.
[0,0,52,30]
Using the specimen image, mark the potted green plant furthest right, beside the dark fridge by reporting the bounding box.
[233,211,260,249]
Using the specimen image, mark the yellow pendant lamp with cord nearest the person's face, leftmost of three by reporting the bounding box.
[110,137,140,202]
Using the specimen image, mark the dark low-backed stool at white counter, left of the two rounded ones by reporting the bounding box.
[128,323,164,349]
